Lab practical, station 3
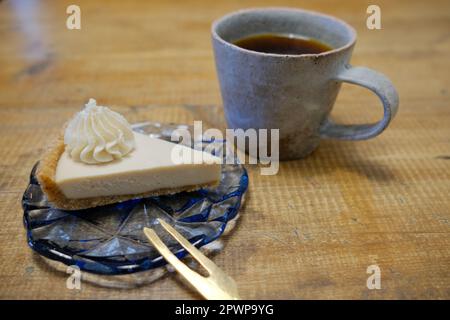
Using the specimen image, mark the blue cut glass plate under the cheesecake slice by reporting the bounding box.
[22,123,248,275]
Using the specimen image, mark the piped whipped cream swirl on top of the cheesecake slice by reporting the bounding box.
[64,99,135,164]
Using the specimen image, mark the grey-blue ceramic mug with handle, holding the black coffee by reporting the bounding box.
[211,8,398,160]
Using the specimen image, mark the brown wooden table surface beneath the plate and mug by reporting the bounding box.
[0,0,450,299]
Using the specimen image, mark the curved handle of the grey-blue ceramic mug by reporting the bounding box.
[320,65,398,140]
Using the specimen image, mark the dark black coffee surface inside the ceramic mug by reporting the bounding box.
[233,33,333,54]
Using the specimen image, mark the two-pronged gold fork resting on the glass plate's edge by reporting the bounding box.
[144,219,240,300]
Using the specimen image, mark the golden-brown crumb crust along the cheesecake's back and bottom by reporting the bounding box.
[36,134,219,210]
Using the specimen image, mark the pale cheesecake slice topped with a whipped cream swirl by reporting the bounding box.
[37,99,221,210]
